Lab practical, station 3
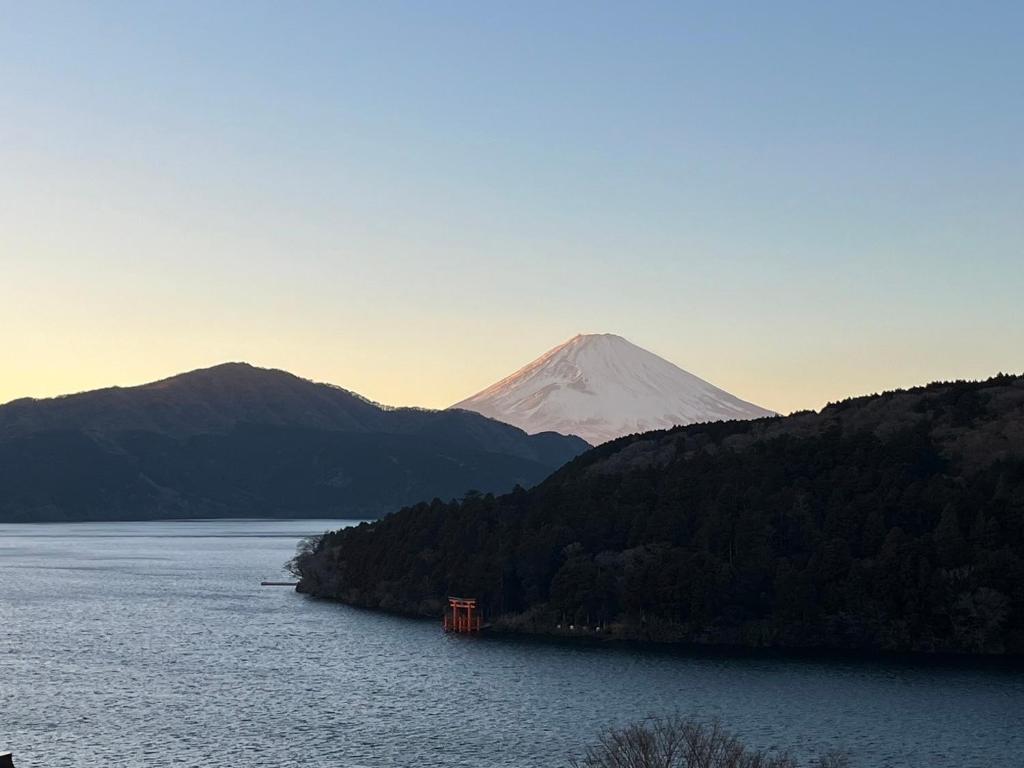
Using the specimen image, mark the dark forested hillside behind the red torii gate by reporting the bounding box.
[293,376,1024,654]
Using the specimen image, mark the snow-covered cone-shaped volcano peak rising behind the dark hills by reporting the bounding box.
[452,334,774,445]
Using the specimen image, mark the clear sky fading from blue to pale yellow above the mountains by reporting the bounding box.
[0,0,1024,412]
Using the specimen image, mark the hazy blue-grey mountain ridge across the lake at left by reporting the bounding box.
[0,364,588,521]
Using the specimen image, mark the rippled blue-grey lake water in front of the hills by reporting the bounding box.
[0,520,1024,768]
